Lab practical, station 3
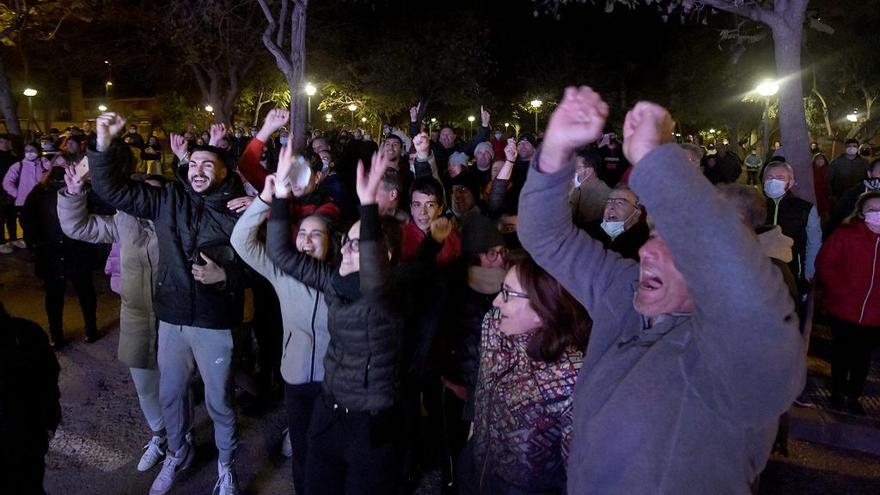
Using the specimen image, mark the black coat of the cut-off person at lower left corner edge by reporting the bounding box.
[0,304,61,458]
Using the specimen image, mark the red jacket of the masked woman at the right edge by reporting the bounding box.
[816,219,880,326]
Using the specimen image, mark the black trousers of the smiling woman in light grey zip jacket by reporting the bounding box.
[284,382,321,493]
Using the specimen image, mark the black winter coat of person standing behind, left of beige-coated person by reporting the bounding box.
[21,174,109,280]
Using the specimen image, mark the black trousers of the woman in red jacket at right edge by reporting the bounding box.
[831,317,880,399]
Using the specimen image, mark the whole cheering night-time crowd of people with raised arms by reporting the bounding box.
[0,87,880,495]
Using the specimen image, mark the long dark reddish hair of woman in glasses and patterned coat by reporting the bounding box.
[512,255,593,363]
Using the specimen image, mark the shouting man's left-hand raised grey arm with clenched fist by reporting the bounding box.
[517,87,638,316]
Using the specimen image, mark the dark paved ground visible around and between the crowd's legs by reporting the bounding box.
[0,246,880,495]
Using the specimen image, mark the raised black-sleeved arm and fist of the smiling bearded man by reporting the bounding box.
[89,112,165,219]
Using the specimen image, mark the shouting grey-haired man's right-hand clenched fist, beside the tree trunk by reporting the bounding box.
[623,101,675,165]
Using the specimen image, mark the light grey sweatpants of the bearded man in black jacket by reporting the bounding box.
[158,321,238,464]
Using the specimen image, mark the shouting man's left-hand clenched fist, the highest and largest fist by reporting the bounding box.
[540,86,608,173]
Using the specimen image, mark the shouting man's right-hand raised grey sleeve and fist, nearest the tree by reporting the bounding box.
[623,102,805,421]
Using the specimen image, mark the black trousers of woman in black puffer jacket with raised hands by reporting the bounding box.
[305,392,400,495]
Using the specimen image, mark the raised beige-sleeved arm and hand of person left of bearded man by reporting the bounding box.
[58,167,119,244]
